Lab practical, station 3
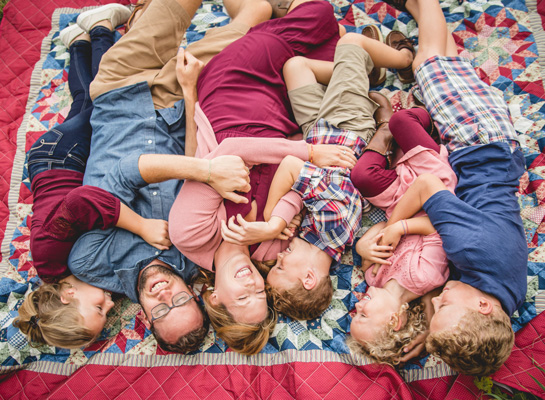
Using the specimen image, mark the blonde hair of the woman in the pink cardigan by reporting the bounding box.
[198,268,276,356]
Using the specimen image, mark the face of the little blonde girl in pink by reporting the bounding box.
[350,286,401,343]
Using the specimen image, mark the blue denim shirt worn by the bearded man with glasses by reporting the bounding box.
[68,82,196,302]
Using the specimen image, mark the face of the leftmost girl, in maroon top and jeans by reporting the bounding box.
[61,275,114,336]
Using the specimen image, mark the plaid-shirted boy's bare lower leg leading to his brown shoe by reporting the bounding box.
[338,33,413,69]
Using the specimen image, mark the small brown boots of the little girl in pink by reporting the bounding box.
[364,92,395,169]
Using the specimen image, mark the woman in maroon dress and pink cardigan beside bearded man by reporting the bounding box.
[169,0,355,354]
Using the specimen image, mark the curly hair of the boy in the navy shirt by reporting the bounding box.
[426,309,515,376]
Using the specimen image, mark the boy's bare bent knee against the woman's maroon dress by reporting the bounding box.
[283,57,333,91]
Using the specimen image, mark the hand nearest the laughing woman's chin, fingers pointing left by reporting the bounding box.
[221,214,285,246]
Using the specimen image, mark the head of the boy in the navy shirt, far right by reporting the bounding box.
[426,281,515,376]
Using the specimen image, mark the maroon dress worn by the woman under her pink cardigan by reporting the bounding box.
[197,1,340,231]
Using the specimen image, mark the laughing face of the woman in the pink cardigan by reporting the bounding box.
[210,252,269,324]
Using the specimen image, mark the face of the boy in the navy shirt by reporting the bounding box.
[430,281,482,332]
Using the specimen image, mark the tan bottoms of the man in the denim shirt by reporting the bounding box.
[91,0,250,109]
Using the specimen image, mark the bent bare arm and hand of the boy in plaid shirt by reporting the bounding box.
[221,156,304,245]
